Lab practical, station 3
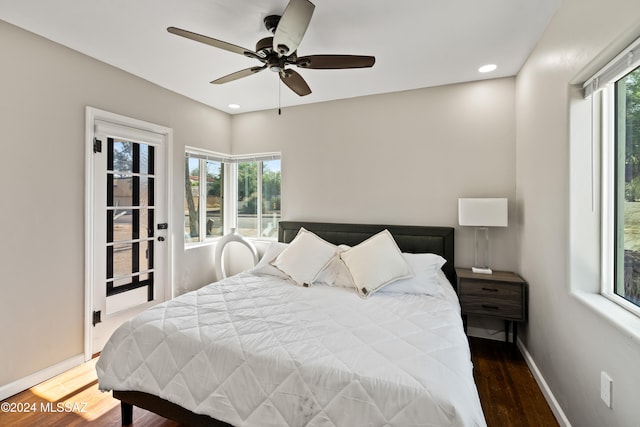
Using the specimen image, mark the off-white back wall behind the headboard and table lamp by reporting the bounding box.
[231,78,517,269]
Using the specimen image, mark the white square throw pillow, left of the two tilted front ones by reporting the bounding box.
[272,228,337,286]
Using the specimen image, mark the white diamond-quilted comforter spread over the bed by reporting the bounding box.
[97,273,486,427]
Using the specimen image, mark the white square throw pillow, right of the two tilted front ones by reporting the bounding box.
[340,230,413,298]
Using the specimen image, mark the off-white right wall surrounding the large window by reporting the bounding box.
[516,0,640,427]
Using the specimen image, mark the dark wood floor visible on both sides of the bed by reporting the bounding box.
[0,338,558,427]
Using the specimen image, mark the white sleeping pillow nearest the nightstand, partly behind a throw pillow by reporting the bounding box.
[380,253,447,296]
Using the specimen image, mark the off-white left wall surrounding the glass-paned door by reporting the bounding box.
[0,21,230,388]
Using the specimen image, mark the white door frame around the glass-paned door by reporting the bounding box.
[84,106,174,361]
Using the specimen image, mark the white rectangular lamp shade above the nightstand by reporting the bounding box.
[458,198,509,227]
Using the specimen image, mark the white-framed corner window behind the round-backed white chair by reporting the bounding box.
[184,149,281,244]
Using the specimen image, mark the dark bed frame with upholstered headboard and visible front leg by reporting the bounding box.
[113,221,457,427]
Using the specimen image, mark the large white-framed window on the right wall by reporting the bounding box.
[584,35,640,315]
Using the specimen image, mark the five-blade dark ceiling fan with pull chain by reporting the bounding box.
[167,0,376,96]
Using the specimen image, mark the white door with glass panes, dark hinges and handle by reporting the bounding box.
[88,108,170,354]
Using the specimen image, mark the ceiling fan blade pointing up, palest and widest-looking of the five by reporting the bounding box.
[273,0,315,56]
